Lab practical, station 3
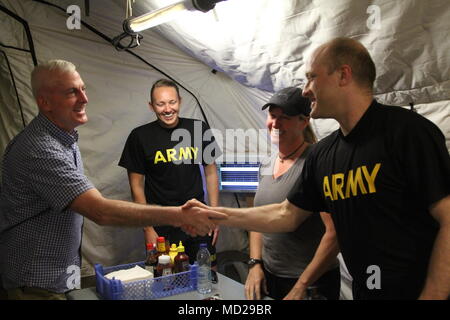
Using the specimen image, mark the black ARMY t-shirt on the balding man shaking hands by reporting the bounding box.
[288,101,450,299]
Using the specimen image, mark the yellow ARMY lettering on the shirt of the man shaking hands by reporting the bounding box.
[323,163,381,201]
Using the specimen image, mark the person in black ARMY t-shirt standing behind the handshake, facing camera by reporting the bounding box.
[119,79,220,266]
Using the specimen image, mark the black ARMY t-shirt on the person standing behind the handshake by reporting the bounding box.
[119,118,220,206]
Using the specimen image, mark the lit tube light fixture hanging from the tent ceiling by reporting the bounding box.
[112,0,226,50]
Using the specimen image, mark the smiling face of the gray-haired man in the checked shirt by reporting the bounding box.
[37,71,88,132]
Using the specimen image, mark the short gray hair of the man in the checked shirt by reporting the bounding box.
[31,59,77,98]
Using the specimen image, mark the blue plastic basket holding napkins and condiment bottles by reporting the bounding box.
[94,262,197,300]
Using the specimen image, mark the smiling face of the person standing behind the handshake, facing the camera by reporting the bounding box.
[150,87,181,128]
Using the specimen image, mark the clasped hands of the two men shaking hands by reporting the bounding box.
[180,199,228,236]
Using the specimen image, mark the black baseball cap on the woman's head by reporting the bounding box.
[262,87,311,116]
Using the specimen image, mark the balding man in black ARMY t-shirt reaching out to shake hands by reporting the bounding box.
[188,38,450,299]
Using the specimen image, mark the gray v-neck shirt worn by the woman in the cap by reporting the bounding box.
[254,146,337,278]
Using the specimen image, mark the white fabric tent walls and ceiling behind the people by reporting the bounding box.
[0,0,450,300]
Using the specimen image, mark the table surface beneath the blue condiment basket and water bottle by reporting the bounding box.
[67,273,271,300]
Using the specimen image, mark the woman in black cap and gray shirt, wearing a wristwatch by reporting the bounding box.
[245,87,340,299]
